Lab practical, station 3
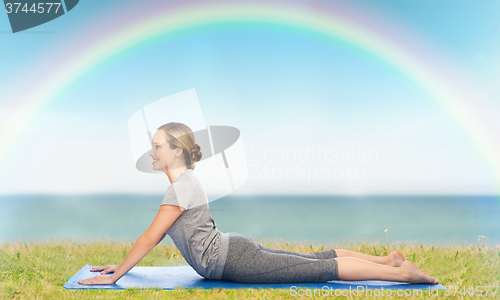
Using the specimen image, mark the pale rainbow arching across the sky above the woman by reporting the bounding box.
[0,1,500,195]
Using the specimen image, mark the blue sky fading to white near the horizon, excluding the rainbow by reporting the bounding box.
[0,0,500,194]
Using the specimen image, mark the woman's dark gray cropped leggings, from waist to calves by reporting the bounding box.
[221,232,338,283]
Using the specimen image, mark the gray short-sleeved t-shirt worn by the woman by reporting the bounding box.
[161,169,229,279]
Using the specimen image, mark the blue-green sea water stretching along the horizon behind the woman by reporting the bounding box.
[0,194,500,247]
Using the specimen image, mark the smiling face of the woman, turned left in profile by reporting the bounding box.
[149,130,182,172]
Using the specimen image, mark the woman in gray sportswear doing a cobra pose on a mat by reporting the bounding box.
[79,122,438,284]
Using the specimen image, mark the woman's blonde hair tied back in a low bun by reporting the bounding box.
[158,122,202,170]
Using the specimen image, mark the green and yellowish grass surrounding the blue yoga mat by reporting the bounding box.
[0,239,500,299]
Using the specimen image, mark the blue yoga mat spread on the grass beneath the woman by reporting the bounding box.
[64,265,445,290]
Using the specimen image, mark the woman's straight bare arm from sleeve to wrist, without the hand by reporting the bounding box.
[111,205,182,282]
